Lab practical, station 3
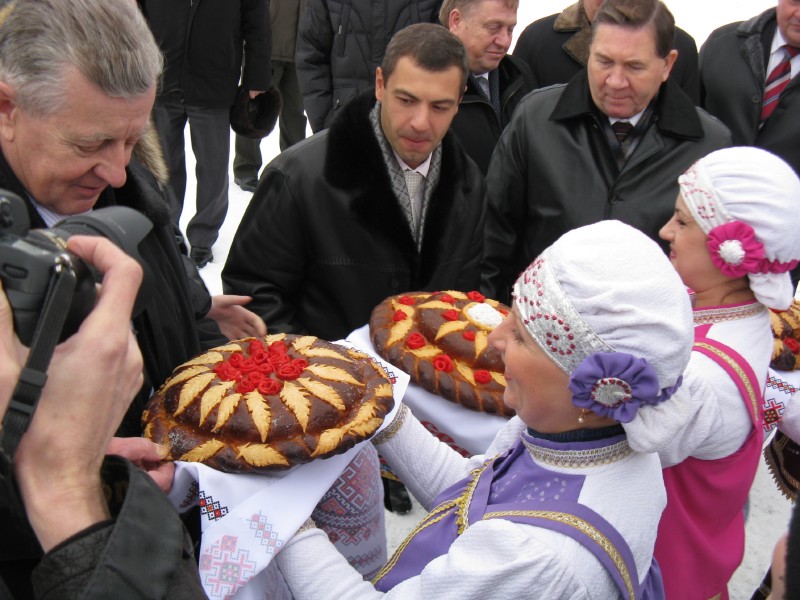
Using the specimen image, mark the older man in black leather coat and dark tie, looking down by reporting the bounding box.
[482,0,730,300]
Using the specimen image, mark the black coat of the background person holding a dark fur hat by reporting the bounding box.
[139,0,272,108]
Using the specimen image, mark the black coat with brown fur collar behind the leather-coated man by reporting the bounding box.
[514,4,699,104]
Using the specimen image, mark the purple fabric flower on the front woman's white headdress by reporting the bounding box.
[569,352,683,423]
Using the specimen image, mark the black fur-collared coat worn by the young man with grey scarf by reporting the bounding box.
[222,94,485,340]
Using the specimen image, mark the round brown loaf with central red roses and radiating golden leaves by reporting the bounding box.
[143,334,394,473]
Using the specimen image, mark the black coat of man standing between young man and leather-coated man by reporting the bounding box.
[450,55,533,175]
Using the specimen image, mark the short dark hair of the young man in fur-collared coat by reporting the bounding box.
[381,23,469,87]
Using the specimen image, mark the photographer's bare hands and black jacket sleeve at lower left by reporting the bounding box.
[0,237,205,600]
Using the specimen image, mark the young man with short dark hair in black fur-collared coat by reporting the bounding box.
[222,24,485,574]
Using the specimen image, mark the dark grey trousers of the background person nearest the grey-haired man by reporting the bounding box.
[153,96,231,248]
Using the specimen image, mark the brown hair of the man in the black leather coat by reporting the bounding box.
[592,0,675,58]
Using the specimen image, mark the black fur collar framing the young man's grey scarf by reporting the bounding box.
[323,92,478,281]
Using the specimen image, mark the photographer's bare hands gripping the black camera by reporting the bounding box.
[0,236,142,551]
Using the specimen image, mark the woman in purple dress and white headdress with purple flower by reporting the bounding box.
[275,221,692,600]
